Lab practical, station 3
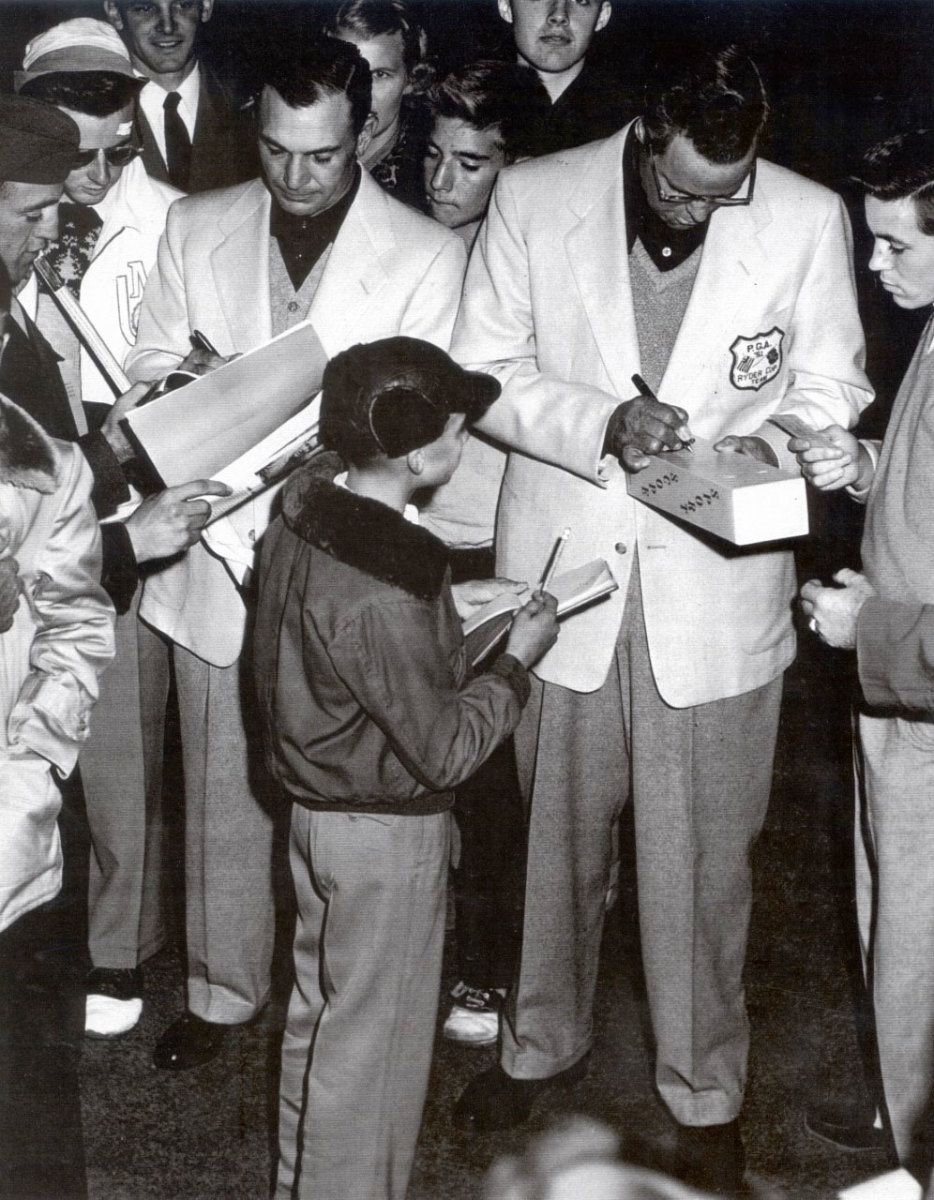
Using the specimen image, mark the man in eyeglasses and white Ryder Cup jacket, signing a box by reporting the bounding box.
[453,44,872,1193]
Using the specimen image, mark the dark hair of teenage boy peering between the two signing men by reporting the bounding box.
[425,59,550,162]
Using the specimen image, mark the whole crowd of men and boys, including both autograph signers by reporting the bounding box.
[0,0,934,1200]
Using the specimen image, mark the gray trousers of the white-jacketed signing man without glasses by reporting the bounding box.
[173,646,275,1025]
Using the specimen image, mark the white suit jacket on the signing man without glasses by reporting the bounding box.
[127,172,465,666]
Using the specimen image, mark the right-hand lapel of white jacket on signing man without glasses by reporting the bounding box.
[309,172,388,354]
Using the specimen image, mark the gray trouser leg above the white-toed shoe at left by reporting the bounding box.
[80,593,168,968]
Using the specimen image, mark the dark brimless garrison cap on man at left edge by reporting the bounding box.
[0,92,80,184]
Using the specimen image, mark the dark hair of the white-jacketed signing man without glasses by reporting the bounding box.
[258,37,371,136]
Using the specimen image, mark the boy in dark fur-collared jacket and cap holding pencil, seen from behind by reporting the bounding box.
[256,337,557,1200]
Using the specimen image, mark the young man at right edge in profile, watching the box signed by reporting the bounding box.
[790,130,934,1178]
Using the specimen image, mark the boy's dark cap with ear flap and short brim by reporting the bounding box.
[319,337,499,462]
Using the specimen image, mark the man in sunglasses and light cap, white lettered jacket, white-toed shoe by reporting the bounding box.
[14,18,230,1038]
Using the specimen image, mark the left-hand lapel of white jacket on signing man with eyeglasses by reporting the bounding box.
[564,126,639,396]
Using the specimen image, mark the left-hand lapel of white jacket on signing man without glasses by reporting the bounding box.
[210,180,273,350]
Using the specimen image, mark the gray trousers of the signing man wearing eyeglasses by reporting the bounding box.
[502,571,782,1126]
